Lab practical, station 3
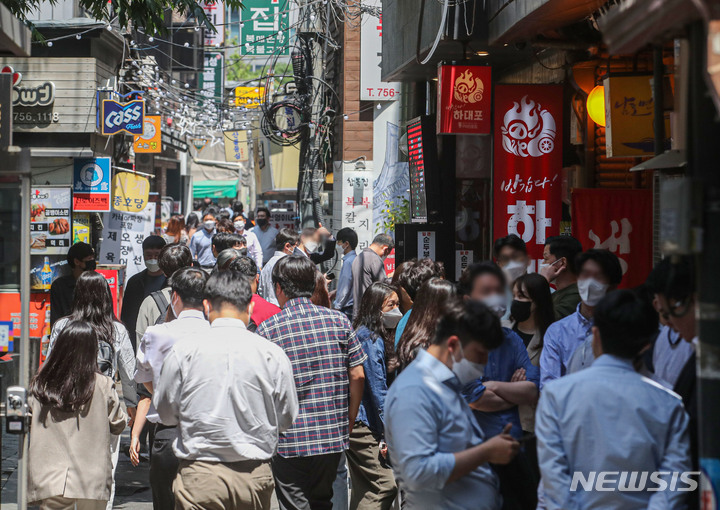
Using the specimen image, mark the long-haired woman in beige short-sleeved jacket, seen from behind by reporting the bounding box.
[28,320,127,510]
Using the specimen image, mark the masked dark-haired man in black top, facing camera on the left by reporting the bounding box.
[120,235,166,349]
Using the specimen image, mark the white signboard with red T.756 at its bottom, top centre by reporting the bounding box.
[360,0,400,101]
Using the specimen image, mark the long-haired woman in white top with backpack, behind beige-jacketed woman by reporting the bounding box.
[48,271,137,508]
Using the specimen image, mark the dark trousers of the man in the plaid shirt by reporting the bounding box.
[272,453,342,510]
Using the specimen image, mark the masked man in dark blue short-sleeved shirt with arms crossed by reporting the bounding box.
[458,262,540,509]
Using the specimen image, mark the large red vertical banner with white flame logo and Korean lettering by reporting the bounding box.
[492,85,563,271]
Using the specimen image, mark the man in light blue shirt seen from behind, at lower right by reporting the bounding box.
[535,290,697,510]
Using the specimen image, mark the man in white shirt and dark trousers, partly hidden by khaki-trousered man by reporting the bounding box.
[130,267,210,510]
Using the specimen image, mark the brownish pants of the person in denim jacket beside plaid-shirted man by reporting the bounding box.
[345,424,397,510]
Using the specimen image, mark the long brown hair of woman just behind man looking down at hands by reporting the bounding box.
[397,278,457,370]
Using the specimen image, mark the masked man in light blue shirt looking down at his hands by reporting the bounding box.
[385,300,520,510]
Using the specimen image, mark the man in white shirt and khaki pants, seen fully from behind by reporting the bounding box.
[153,271,298,510]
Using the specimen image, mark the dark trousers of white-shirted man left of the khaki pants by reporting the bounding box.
[150,425,178,510]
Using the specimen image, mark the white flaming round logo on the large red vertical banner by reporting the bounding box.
[501,96,556,158]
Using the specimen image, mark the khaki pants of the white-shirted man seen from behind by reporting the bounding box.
[173,460,275,510]
